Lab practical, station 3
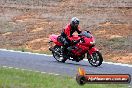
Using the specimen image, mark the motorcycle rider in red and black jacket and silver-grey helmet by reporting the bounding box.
[60,17,81,58]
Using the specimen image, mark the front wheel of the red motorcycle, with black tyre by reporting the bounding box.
[89,51,103,67]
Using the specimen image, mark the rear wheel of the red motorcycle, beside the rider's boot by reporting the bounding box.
[52,45,67,63]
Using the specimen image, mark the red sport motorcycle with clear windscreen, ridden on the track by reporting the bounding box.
[49,31,103,67]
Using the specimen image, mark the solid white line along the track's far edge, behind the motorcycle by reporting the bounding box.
[0,49,132,67]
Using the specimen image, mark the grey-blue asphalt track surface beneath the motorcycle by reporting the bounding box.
[0,50,132,77]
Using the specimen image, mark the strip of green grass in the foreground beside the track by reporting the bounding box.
[0,68,128,88]
